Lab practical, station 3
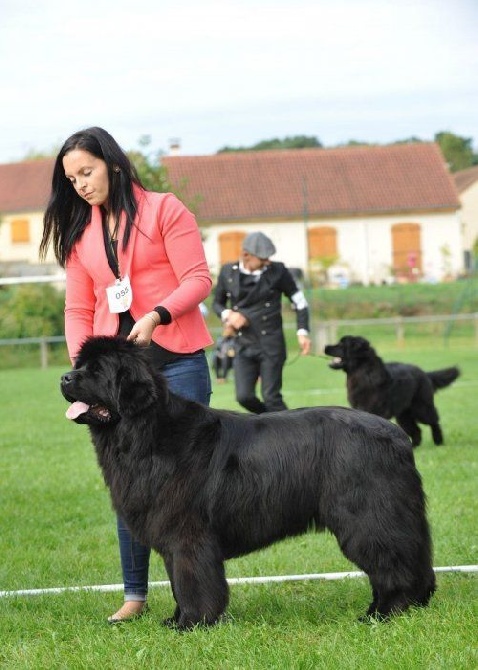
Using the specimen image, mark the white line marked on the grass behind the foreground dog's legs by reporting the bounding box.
[0,565,478,598]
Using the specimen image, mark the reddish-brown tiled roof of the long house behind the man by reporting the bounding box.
[162,143,459,221]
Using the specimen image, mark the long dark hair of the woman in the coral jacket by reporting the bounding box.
[40,127,144,267]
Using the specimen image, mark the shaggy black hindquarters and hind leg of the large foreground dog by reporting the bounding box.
[323,484,434,619]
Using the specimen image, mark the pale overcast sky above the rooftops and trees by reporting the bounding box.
[0,0,478,163]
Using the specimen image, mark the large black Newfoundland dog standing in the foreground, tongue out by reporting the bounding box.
[61,337,435,629]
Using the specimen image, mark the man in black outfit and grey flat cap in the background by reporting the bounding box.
[213,232,311,414]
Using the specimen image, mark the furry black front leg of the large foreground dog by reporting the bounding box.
[168,535,229,630]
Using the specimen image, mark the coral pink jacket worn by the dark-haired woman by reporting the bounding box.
[65,187,213,359]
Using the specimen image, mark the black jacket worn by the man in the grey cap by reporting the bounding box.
[213,262,309,355]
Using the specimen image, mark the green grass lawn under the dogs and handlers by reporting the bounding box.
[0,344,478,670]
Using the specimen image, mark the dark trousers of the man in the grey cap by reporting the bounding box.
[234,349,287,414]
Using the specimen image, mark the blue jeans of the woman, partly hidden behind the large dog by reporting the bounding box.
[117,351,211,601]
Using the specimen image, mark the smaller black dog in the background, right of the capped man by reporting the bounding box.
[324,335,460,447]
